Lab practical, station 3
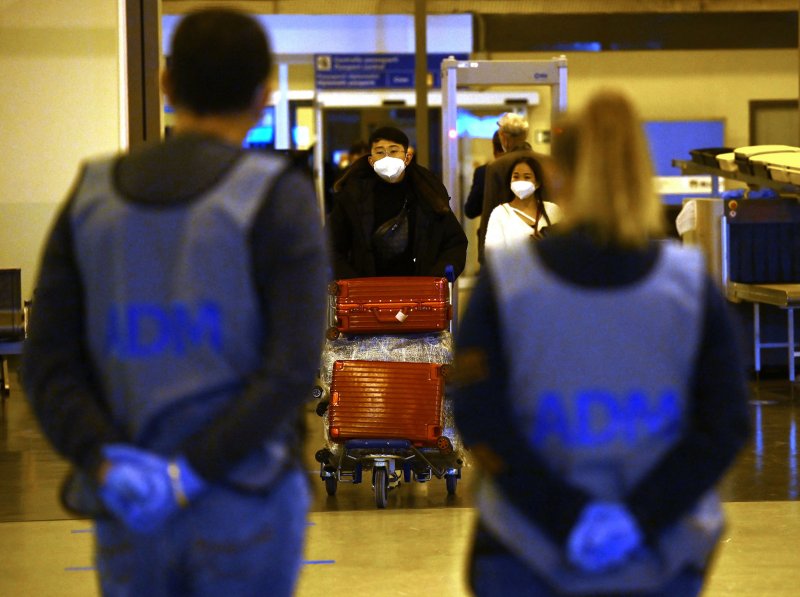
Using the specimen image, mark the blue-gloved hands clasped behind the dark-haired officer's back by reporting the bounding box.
[100,444,205,534]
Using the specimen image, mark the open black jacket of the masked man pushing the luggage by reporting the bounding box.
[328,156,467,279]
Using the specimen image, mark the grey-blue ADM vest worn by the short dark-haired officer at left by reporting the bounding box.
[70,154,286,486]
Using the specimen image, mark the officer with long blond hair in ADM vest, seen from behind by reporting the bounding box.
[454,91,749,597]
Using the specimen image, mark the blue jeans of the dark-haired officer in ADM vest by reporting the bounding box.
[95,469,310,597]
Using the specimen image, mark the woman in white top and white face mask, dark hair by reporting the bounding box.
[486,156,561,247]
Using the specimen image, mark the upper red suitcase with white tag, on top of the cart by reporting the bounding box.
[328,276,453,340]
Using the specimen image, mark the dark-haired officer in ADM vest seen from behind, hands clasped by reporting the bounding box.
[23,10,329,596]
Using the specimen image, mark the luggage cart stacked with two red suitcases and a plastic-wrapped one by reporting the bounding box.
[315,270,462,508]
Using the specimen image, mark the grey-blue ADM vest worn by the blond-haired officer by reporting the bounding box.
[478,243,723,594]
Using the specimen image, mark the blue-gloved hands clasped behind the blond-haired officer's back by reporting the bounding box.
[567,502,642,572]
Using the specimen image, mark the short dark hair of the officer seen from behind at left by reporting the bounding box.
[167,9,272,115]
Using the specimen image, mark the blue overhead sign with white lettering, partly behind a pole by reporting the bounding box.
[314,54,468,90]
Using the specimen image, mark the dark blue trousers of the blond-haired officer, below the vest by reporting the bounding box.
[471,554,703,597]
